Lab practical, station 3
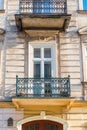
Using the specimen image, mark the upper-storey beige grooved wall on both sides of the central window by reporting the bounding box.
[1,0,82,97]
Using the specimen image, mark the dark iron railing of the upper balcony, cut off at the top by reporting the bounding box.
[19,0,67,14]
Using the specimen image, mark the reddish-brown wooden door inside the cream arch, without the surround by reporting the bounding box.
[22,120,63,130]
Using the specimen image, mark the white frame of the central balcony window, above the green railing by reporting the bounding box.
[28,43,58,78]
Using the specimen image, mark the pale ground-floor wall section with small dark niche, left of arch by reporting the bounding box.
[0,108,23,130]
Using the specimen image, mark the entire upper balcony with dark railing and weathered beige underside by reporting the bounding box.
[15,0,71,36]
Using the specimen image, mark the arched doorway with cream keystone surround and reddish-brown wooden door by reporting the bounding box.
[17,114,68,130]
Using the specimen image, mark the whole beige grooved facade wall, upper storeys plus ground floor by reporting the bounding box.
[0,0,87,130]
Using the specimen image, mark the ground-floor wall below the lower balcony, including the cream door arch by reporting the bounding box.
[0,108,87,130]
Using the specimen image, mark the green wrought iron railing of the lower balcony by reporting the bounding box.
[16,76,70,98]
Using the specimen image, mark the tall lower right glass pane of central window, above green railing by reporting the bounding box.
[44,62,51,78]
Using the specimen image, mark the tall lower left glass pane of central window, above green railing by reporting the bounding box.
[34,62,41,78]
